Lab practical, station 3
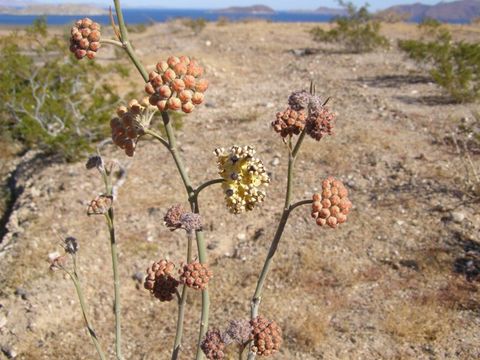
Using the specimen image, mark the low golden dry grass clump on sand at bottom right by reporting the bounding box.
[384,300,455,344]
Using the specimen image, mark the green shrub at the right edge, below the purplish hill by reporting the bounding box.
[398,21,480,102]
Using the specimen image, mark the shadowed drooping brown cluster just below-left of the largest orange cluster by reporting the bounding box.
[110,98,156,156]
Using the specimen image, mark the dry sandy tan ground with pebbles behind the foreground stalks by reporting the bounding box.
[0,22,480,359]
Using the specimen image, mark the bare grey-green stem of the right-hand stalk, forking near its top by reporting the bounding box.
[248,130,310,360]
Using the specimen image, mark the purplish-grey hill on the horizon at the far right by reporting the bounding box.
[384,0,480,22]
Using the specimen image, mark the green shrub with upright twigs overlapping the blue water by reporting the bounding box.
[310,0,388,53]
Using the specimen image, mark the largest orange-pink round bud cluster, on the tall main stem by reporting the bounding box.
[145,56,208,113]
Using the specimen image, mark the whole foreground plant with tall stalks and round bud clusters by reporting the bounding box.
[53,0,352,359]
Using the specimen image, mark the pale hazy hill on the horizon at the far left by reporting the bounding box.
[0,0,108,16]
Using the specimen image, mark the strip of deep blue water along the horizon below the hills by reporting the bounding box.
[0,9,333,25]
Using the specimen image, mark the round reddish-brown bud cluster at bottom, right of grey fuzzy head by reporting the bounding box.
[250,316,282,356]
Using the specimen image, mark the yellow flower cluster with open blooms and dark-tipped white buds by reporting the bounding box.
[215,146,270,214]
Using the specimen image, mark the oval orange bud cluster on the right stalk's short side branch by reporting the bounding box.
[312,177,352,228]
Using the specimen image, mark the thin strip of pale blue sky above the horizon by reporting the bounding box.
[37,0,454,10]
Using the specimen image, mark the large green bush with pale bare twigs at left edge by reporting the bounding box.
[0,19,125,160]
